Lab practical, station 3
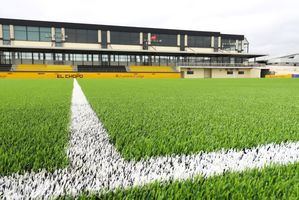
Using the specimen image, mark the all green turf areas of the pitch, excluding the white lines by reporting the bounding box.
[0,79,299,199]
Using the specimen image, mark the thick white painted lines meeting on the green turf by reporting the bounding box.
[0,80,299,199]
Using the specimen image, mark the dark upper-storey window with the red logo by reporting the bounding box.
[151,33,177,46]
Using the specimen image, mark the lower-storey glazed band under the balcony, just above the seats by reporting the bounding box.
[0,51,250,67]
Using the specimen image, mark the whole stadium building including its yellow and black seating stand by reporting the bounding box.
[0,19,263,78]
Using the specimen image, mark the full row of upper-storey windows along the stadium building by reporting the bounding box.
[3,25,236,50]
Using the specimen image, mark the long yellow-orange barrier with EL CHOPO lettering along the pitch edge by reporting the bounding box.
[0,72,180,79]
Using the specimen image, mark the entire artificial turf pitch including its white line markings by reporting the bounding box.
[0,79,299,199]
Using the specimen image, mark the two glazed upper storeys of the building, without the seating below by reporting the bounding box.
[0,19,261,77]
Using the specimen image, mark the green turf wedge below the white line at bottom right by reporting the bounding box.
[78,163,299,200]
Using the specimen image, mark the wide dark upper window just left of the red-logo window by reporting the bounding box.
[110,31,139,45]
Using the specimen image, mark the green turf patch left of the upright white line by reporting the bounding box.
[0,80,73,175]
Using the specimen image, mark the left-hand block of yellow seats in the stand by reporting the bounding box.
[16,64,73,72]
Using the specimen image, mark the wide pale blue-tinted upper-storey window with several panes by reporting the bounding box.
[14,26,51,42]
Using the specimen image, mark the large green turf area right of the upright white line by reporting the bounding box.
[80,79,299,160]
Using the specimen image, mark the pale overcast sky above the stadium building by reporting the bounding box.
[0,0,299,56]
